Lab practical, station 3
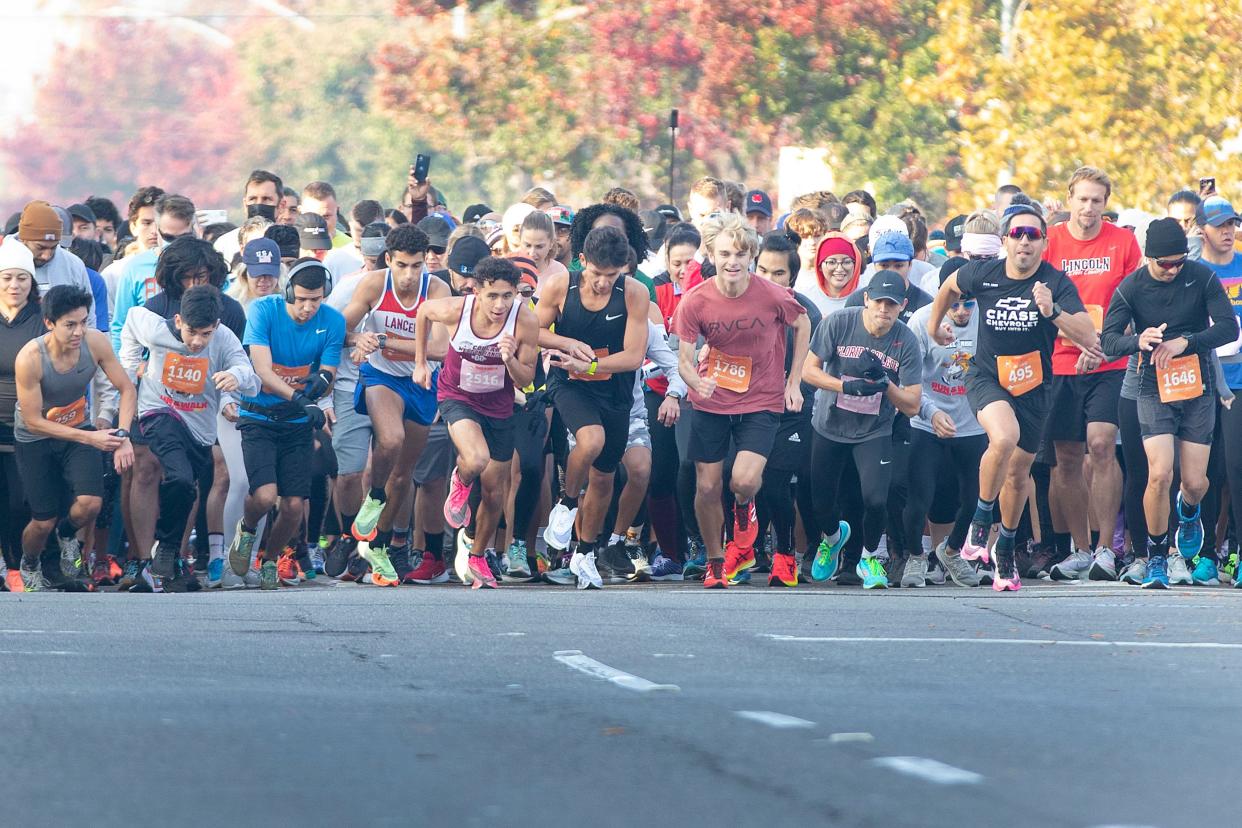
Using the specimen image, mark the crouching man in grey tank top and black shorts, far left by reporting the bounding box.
[12,284,138,592]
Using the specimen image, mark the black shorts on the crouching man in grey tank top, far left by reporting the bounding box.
[14,430,103,520]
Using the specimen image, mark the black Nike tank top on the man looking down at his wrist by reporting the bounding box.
[548,272,635,411]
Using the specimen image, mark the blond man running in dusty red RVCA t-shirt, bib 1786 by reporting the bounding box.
[673,214,811,590]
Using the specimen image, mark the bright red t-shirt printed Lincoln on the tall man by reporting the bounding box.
[1043,221,1143,376]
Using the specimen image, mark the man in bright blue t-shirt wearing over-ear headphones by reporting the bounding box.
[229,258,345,590]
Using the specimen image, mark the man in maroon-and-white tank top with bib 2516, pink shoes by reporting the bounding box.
[414,255,542,590]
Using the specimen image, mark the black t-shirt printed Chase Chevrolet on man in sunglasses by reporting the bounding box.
[956,259,1086,382]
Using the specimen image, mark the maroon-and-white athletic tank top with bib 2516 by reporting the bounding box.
[438,294,522,420]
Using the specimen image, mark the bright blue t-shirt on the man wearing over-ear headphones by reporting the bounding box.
[241,294,345,422]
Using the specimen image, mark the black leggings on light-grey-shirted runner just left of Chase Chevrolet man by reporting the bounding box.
[902,428,987,555]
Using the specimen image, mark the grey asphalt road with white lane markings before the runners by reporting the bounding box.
[0,582,1242,828]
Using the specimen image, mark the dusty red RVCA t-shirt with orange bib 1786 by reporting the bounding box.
[673,276,806,415]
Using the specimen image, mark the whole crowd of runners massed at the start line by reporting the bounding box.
[0,166,1242,592]
